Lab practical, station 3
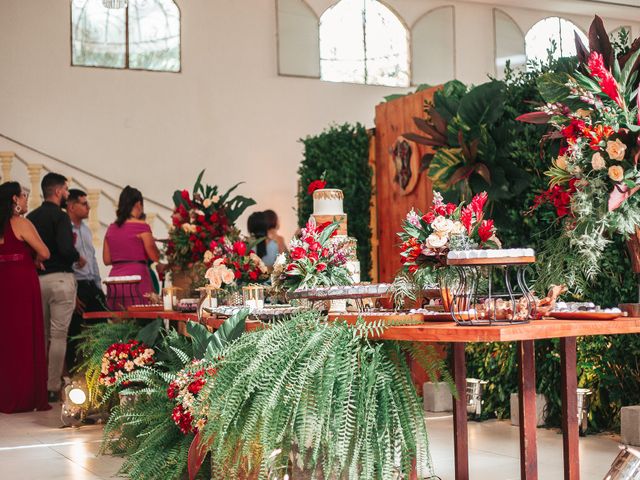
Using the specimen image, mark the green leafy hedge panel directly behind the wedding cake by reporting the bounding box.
[298,123,372,280]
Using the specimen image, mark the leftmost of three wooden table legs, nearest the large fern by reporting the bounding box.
[452,343,469,480]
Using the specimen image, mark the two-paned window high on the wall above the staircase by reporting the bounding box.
[71,0,180,72]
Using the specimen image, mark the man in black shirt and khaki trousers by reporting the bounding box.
[27,173,86,402]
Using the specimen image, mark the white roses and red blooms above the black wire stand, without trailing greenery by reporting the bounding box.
[398,192,500,274]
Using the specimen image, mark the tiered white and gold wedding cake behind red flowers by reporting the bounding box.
[311,188,360,283]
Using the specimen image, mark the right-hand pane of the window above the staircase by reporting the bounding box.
[129,0,180,72]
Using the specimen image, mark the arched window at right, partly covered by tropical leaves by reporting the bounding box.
[525,17,589,61]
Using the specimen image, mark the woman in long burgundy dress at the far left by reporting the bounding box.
[0,182,51,413]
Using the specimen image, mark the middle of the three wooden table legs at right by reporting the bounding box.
[517,340,538,480]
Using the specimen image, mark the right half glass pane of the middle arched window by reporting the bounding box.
[364,0,409,87]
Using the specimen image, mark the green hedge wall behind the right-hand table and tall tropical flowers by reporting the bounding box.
[440,59,640,430]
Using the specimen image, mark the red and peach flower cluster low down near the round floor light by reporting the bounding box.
[98,340,155,387]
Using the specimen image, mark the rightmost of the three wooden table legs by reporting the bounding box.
[560,337,580,480]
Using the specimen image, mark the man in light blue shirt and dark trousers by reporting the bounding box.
[66,188,106,370]
